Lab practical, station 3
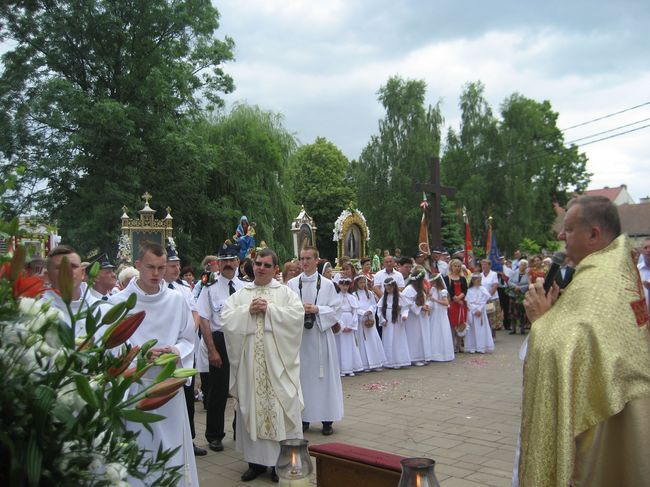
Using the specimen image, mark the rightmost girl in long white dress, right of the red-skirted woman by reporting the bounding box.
[465,274,494,353]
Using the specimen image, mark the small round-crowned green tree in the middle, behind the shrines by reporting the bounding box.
[290,137,355,262]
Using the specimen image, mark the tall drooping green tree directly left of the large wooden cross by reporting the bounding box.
[350,76,442,255]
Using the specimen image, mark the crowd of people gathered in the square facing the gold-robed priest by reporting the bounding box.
[31,193,650,485]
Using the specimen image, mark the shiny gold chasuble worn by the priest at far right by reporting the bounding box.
[519,236,650,487]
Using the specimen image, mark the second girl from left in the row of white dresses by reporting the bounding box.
[353,274,386,371]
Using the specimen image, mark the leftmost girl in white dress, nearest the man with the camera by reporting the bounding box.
[338,277,364,377]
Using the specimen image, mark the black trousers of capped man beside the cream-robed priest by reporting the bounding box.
[205,331,230,441]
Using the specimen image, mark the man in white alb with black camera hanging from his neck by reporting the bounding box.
[287,247,343,436]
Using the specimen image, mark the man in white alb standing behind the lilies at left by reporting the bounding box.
[110,242,198,486]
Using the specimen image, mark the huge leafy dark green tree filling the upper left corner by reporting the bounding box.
[0,0,234,255]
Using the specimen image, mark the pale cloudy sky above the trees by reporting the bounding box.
[214,0,650,201]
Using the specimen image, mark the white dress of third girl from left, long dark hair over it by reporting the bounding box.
[377,295,411,369]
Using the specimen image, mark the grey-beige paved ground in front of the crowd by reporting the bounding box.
[195,331,523,487]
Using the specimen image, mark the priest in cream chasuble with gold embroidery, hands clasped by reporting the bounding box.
[221,248,304,482]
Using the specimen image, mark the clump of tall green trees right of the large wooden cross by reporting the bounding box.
[442,82,590,251]
